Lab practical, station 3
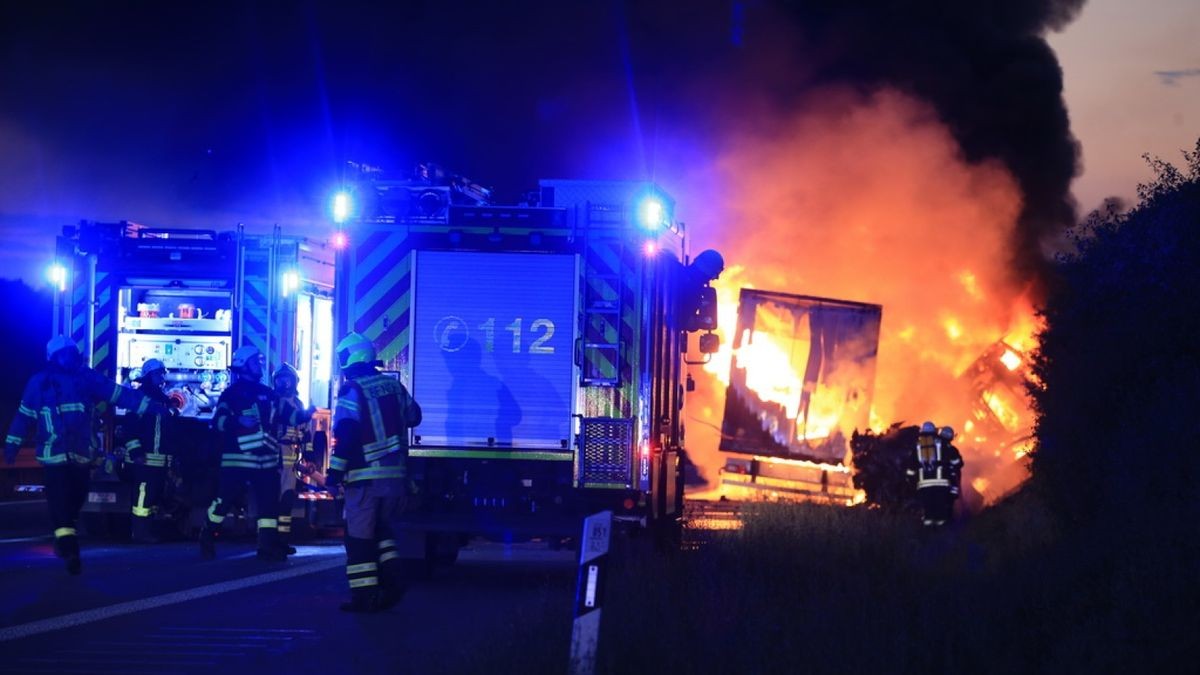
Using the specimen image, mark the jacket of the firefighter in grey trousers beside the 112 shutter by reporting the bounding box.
[329,364,421,484]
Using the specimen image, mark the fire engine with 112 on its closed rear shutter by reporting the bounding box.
[334,171,720,558]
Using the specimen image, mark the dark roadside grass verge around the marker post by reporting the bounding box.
[448,490,1200,675]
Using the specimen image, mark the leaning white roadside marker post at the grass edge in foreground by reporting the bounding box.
[569,510,612,675]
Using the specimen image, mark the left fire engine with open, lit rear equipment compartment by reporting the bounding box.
[52,221,334,530]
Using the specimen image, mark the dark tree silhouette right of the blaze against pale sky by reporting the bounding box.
[1031,141,1200,527]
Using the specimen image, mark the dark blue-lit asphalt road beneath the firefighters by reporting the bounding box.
[0,504,576,675]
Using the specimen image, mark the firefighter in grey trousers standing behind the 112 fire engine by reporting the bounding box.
[325,333,421,613]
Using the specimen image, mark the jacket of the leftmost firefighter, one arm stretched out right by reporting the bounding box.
[5,364,163,466]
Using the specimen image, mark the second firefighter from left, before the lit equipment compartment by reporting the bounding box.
[125,359,176,544]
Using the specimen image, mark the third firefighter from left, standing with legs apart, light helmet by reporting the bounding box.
[200,345,310,562]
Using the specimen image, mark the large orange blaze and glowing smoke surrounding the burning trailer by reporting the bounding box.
[680,85,1038,501]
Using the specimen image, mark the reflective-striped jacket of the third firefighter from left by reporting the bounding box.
[212,377,307,471]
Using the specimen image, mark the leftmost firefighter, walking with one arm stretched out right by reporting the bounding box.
[4,335,166,574]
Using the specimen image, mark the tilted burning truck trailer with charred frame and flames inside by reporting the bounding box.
[719,288,883,503]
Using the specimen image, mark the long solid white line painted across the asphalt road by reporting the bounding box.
[0,555,346,643]
